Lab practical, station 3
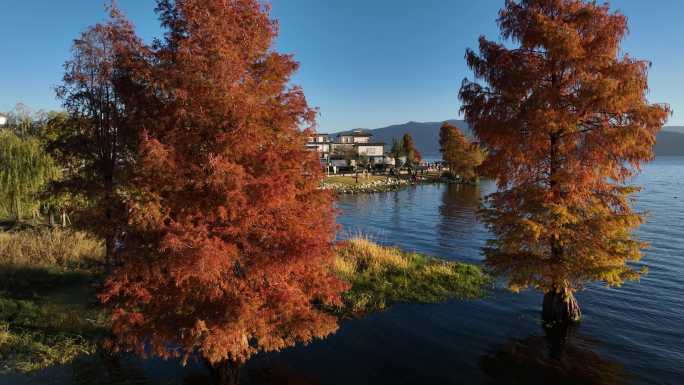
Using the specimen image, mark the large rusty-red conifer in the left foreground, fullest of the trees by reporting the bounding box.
[101,0,345,382]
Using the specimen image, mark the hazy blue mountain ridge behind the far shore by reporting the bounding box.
[336,120,684,157]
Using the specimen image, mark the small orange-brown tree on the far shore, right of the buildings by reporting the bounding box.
[439,122,484,181]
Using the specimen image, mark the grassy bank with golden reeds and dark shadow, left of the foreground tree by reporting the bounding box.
[0,228,107,373]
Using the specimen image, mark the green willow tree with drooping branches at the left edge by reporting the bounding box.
[0,129,58,222]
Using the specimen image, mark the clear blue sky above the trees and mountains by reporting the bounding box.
[0,0,684,132]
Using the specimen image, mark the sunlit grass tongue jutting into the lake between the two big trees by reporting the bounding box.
[334,237,492,316]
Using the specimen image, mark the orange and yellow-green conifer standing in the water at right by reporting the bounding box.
[460,0,669,321]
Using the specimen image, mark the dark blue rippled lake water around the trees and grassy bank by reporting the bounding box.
[6,157,684,385]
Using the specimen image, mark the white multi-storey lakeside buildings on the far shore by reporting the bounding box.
[306,129,394,167]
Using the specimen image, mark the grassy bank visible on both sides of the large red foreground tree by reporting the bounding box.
[0,229,489,373]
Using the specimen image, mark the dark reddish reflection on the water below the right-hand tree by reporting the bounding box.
[480,326,632,385]
